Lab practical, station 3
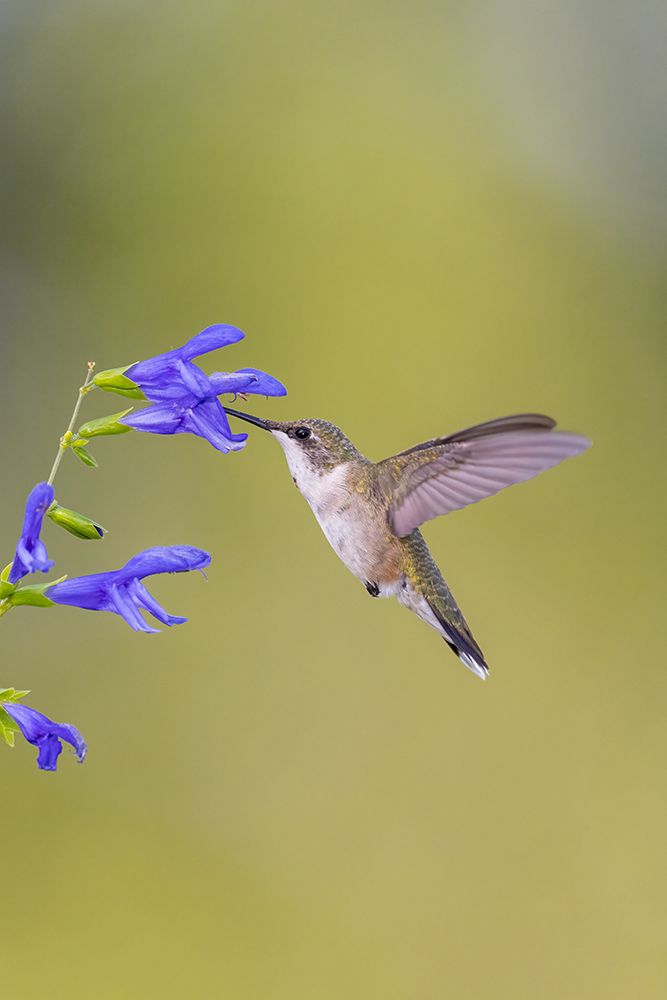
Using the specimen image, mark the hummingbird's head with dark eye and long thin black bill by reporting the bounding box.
[225,406,365,487]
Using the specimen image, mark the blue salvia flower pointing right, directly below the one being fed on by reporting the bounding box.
[44,545,211,632]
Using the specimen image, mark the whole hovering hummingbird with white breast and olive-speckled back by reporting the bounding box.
[225,406,591,679]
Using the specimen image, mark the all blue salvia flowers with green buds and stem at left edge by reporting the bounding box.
[0,325,286,771]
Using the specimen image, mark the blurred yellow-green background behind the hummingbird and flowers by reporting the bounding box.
[0,0,667,1000]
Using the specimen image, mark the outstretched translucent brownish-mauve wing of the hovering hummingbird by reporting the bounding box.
[377,413,591,538]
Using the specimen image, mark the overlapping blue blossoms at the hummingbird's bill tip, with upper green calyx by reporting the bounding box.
[95,325,287,452]
